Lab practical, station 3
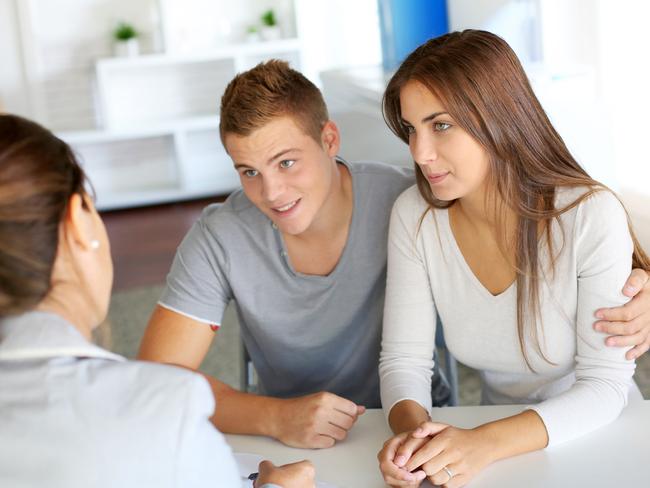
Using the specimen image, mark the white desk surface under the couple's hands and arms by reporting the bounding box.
[226,400,650,488]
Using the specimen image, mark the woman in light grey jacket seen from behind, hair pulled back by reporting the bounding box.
[0,115,314,488]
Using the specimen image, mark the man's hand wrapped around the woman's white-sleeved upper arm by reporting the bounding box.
[594,269,650,359]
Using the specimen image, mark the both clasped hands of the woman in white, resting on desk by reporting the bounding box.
[377,422,491,488]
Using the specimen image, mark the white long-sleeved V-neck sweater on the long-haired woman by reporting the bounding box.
[379,187,636,446]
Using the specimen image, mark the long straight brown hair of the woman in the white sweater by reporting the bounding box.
[383,30,650,369]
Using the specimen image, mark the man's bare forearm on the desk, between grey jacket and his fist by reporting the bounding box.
[204,375,283,438]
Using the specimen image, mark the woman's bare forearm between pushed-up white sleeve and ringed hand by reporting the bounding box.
[474,410,548,462]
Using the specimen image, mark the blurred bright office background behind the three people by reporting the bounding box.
[0,0,650,402]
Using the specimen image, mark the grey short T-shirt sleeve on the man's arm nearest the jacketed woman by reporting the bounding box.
[159,217,232,324]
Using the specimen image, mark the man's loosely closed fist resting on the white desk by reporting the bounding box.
[273,392,366,448]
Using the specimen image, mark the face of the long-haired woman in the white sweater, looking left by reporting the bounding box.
[400,81,490,201]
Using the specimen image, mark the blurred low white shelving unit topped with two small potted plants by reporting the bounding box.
[52,39,301,210]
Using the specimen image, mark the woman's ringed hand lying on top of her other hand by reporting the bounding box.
[390,422,494,488]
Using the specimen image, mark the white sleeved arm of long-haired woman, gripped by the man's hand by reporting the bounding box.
[531,191,634,446]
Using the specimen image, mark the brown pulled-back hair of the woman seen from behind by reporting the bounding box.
[0,114,86,317]
